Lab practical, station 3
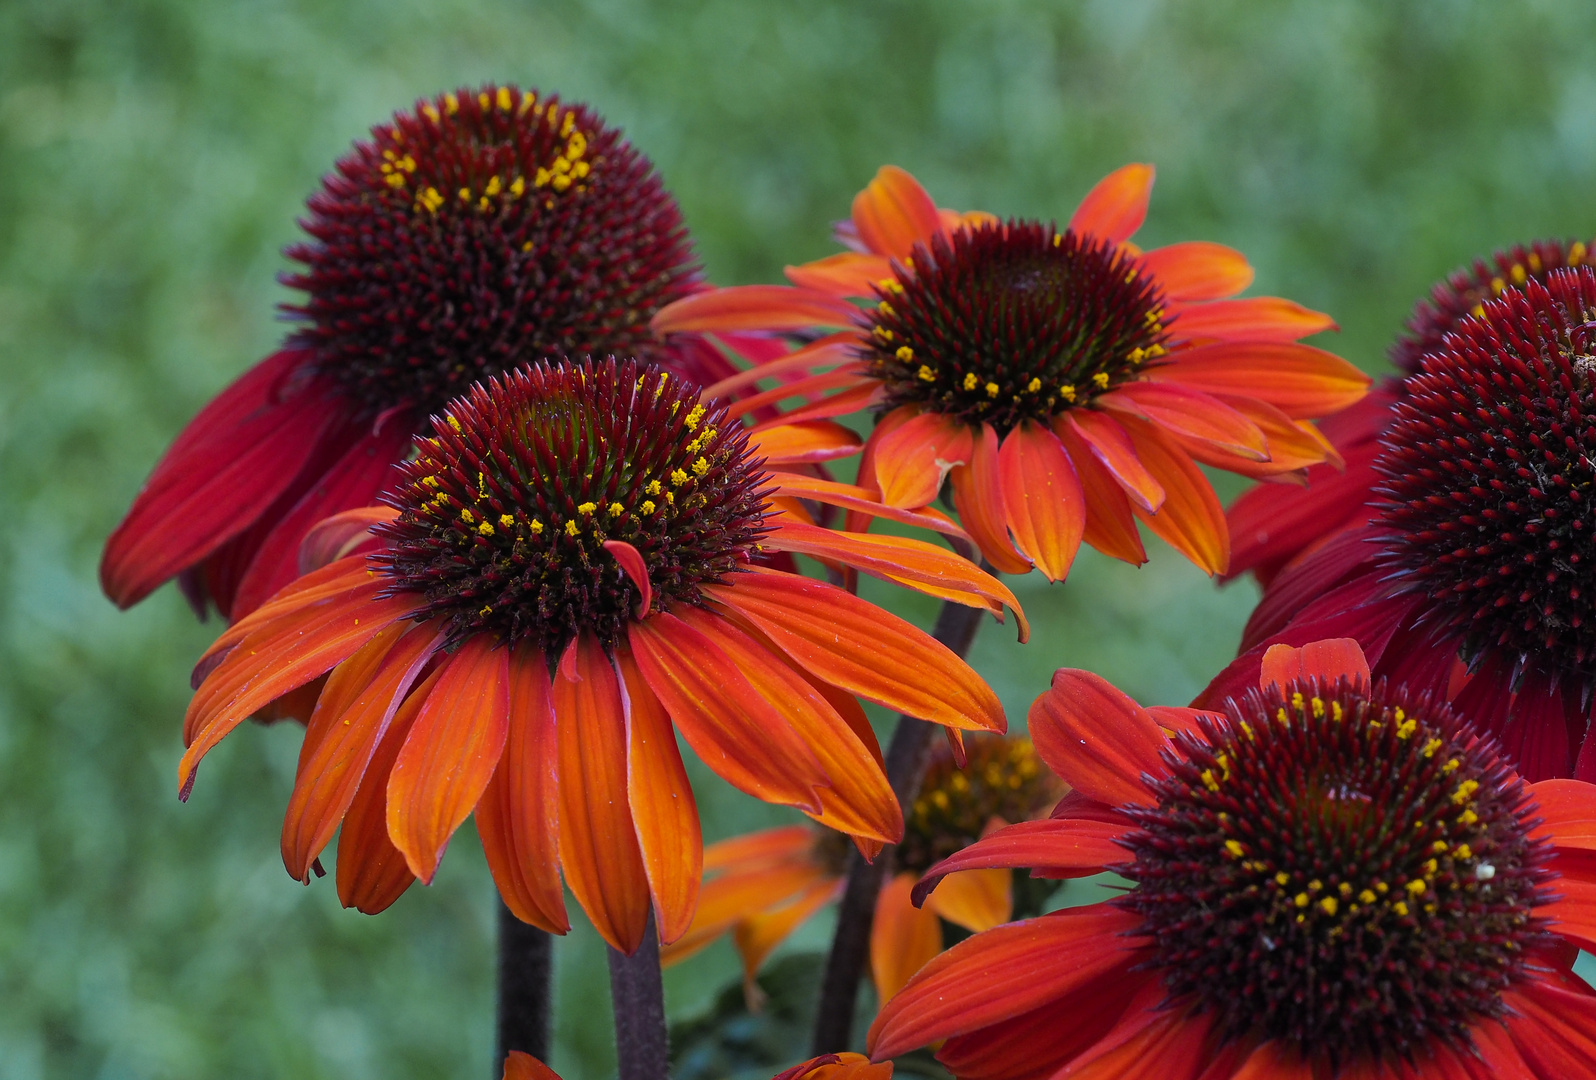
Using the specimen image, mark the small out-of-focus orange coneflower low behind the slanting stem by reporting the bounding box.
[662,735,1065,1002]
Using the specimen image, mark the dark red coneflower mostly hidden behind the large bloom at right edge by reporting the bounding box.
[1226,239,1591,587]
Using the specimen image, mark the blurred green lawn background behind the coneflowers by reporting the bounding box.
[0,0,1596,1080]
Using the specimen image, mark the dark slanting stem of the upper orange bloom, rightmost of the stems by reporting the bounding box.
[812,600,985,1054]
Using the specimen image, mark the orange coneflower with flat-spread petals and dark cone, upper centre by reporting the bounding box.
[654,164,1369,579]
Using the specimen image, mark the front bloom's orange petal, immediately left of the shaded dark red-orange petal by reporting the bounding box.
[281,624,440,882]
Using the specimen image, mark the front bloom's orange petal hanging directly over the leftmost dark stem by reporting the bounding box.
[477,641,571,933]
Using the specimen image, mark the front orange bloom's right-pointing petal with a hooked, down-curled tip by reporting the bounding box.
[763,517,1031,641]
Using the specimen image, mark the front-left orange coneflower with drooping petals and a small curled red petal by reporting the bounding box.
[179,361,1012,952]
